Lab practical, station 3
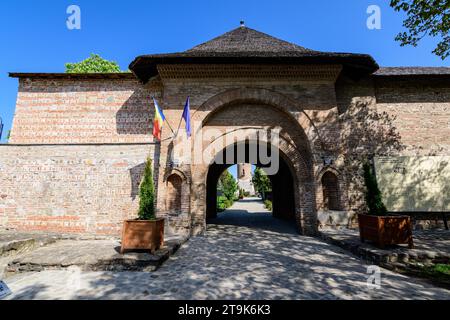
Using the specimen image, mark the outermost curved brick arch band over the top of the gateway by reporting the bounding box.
[192,87,323,142]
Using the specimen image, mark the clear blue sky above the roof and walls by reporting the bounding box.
[0,0,444,142]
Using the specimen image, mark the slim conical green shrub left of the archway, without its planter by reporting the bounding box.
[139,157,155,220]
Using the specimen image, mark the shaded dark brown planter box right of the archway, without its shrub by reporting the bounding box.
[358,214,414,249]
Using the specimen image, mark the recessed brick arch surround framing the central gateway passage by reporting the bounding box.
[191,88,318,235]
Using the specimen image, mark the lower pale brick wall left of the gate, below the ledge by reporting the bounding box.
[0,144,158,235]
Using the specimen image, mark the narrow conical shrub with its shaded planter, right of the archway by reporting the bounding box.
[358,162,414,248]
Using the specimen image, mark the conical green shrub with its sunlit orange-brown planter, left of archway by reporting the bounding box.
[120,157,164,253]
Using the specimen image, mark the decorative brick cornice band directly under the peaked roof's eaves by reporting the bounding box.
[157,64,342,81]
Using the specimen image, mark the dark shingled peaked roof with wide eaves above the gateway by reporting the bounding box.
[129,26,378,83]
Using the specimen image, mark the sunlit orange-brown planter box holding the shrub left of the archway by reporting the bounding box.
[120,219,164,253]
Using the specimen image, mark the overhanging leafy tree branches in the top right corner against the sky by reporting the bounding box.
[390,0,450,60]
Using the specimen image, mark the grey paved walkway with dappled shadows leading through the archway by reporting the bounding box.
[3,199,450,299]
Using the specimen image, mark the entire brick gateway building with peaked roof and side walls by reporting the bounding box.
[0,26,450,238]
